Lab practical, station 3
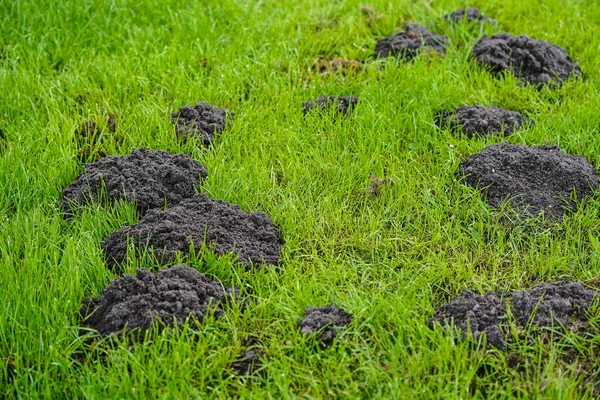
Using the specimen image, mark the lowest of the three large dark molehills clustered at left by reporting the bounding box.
[81,264,237,336]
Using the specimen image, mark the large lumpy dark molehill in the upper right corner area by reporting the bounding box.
[472,33,581,85]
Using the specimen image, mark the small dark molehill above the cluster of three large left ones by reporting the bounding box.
[171,102,233,146]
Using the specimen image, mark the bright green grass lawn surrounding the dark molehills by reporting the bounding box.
[0,0,600,399]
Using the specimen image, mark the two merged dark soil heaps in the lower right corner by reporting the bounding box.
[429,281,596,349]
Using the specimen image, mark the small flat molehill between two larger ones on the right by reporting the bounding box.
[435,104,526,138]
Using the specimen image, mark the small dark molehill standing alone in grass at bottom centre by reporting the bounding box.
[296,304,354,347]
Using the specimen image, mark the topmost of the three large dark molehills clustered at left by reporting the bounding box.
[61,148,208,215]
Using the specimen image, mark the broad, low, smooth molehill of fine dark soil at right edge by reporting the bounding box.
[459,142,598,219]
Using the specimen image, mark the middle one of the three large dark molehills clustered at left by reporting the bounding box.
[102,193,283,268]
